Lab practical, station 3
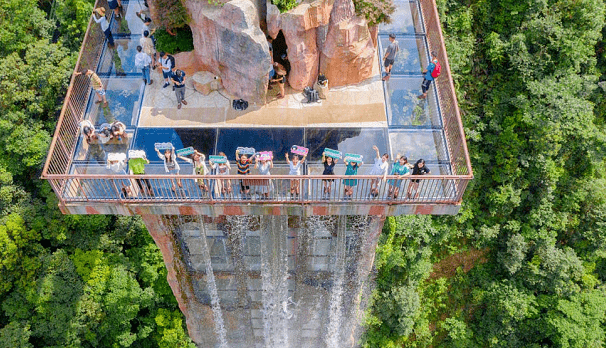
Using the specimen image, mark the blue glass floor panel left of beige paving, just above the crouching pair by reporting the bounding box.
[84,78,145,127]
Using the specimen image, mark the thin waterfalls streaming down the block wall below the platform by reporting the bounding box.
[171,216,380,348]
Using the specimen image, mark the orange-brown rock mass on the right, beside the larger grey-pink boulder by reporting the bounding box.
[267,0,376,89]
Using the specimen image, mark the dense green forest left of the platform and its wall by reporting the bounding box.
[0,0,193,348]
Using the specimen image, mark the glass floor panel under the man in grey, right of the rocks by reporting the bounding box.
[379,35,429,77]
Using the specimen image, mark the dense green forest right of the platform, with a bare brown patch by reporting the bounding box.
[365,0,606,348]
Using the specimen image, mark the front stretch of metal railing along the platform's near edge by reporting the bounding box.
[47,174,469,204]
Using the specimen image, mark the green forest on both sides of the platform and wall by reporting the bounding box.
[0,0,606,348]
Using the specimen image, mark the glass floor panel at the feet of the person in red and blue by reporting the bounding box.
[385,76,442,127]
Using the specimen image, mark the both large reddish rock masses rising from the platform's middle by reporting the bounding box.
[149,0,376,103]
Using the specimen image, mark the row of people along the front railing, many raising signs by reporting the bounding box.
[80,125,430,200]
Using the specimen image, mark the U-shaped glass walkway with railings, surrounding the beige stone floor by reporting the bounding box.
[42,0,473,215]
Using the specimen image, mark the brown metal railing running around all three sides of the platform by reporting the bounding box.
[42,0,473,205]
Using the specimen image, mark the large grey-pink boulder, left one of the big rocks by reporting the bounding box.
[184,0,271,103]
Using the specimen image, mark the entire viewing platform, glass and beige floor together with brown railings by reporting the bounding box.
[42,0,473,216]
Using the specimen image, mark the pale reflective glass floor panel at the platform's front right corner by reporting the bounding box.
[389,129,448,163]
